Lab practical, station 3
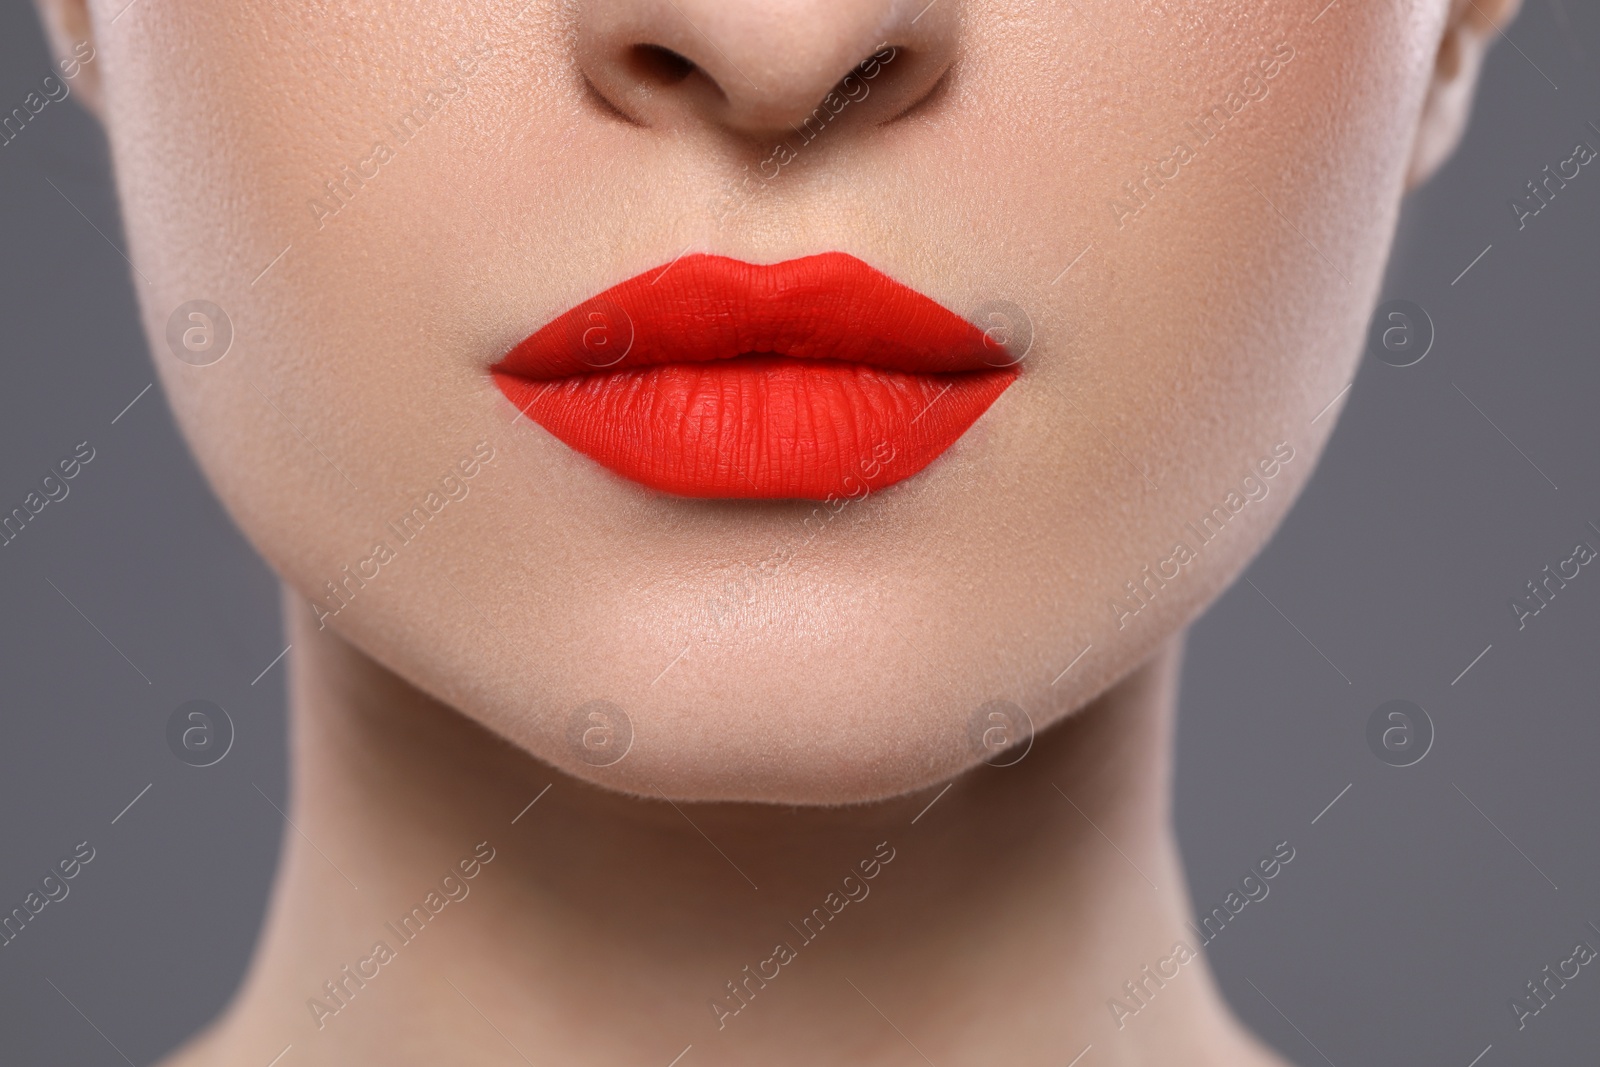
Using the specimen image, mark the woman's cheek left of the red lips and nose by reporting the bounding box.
[104,3,570,608]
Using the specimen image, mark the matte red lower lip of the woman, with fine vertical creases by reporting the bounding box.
[494,355,1018,501]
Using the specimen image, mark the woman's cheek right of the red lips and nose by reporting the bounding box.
[838,2,1432,723]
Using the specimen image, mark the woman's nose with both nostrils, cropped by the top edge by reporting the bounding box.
[578,0,962,138]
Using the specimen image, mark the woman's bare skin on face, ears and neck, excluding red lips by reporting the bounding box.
[38,0,1515,1067]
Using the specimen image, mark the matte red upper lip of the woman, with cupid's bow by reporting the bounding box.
[496,251,1011,379]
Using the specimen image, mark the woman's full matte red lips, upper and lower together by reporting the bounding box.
[491,253,1018,499]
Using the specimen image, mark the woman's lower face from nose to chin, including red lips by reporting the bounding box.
[94,0,1446,803]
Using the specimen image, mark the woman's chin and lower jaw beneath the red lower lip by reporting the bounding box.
[308,511,1203,805]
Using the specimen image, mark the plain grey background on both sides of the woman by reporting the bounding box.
[0,0,1600,1067]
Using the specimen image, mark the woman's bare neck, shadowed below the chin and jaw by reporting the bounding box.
[181,598,1269,1067]
